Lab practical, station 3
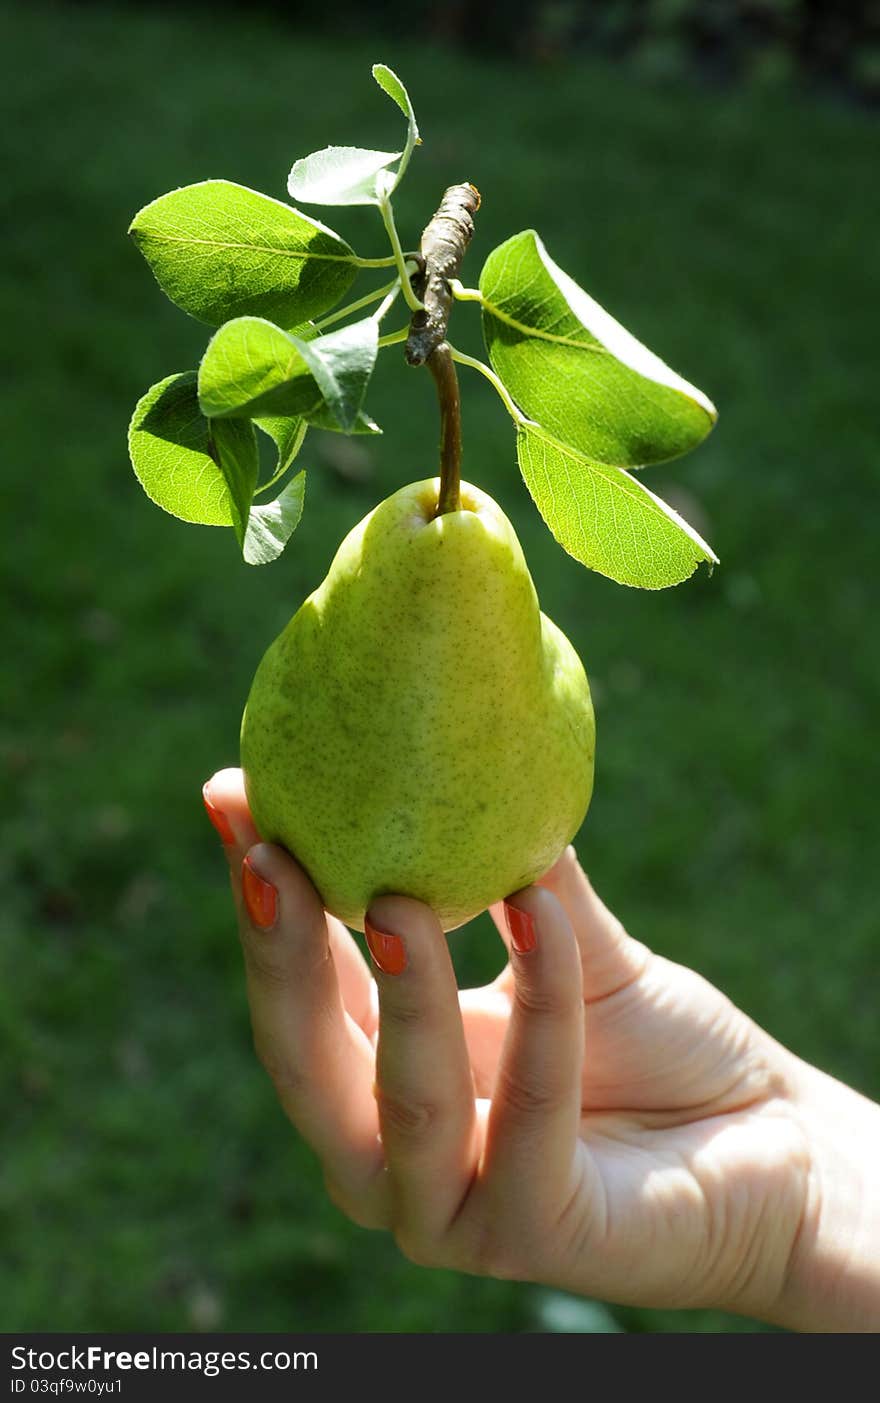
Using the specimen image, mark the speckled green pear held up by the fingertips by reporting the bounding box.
[241,478,595,930]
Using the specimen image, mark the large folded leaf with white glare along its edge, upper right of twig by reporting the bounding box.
[480,230,716,467]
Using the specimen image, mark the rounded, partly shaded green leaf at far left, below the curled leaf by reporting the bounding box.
[128,372,258,526]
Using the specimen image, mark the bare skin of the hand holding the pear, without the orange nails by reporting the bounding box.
[206,770,880,1333]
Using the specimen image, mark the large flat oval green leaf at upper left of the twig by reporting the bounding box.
[129,180,358,327]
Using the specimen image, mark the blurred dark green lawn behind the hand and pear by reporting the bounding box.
[0,0,880,1333]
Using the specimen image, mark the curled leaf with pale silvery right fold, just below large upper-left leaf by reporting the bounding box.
[198,317,379,434]
